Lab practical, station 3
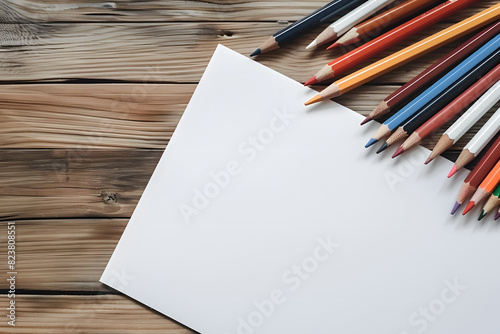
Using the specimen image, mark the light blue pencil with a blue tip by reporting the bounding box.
[365,33,500,147]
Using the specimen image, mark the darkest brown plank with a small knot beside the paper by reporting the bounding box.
[0,148,161,220]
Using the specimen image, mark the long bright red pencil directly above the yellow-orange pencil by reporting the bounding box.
[306,0,477,85]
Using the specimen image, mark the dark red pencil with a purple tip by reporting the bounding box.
[451,136,500,215]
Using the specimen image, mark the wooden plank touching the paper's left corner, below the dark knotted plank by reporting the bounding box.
[0,218,128,293]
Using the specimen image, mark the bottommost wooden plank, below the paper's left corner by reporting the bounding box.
[0,294,196,334]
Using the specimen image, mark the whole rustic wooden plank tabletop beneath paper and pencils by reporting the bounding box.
[0,0,498,334]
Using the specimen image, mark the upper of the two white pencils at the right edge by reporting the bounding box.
[429,81,500,163]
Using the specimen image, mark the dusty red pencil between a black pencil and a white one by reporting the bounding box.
[392,64,500,158]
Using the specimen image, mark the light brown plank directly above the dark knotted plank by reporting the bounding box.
[0,84,496,149]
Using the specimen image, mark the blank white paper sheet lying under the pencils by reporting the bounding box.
[101,46,500,334]
